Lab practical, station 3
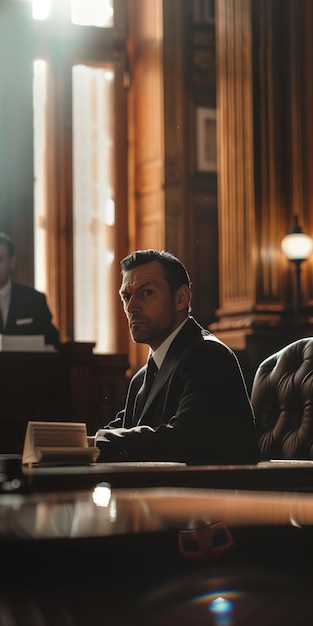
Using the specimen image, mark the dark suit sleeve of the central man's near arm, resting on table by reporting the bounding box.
[97,341,259,465]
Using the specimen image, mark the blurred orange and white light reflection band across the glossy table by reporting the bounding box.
[0,482,313,538]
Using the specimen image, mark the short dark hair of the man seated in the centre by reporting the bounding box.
[120,249,191,294]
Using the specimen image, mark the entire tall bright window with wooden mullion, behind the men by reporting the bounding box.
[32,0,127,353]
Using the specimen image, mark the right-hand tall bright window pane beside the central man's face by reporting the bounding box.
[73,65,116,352]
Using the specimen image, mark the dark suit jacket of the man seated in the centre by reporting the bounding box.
[96,317,260,465]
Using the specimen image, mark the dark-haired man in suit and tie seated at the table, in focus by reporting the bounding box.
[89,250,259,465]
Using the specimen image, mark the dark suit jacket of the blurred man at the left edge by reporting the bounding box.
[4,280,59,346]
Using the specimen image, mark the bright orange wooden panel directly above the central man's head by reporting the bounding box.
[129,0,164,248]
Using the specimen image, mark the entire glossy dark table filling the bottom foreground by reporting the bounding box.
[0,462,313,626]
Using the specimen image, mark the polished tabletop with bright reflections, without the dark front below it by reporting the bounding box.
[0,455,313,539]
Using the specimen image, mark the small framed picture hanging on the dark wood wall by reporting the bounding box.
[196,107,217,172]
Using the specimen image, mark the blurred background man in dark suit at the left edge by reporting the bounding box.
[0,233,59,346]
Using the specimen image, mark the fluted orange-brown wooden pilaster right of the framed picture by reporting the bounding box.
[216,0,255,316]
